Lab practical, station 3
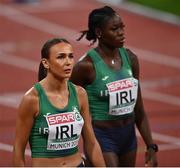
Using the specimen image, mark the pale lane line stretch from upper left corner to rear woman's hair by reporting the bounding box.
[0,5,89,44]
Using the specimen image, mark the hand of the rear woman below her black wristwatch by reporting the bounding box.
[145,149,158,167]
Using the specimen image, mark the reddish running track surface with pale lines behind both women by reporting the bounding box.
[0,0,180,166]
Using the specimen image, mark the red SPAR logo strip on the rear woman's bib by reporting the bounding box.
[107,79,133,92]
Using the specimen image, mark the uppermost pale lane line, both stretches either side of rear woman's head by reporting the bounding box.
[0,5,180,69]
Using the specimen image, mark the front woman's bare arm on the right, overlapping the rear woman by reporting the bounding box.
[77,86,105,167]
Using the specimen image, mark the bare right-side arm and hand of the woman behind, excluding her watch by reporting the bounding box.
[127,49,157,166]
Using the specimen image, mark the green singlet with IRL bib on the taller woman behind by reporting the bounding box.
[85,48,138,120]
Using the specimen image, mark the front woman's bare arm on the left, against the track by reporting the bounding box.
[13,88,39,166]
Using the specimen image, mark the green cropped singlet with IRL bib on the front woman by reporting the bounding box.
[29,82,84,158]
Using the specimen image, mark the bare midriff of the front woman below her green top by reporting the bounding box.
[32,152,83,167]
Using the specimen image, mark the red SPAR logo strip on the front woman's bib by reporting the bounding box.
[47,112,75,125]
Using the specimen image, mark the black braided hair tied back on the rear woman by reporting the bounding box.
[77,6,116,44]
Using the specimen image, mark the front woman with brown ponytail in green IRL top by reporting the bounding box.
[13,38,105,167]
